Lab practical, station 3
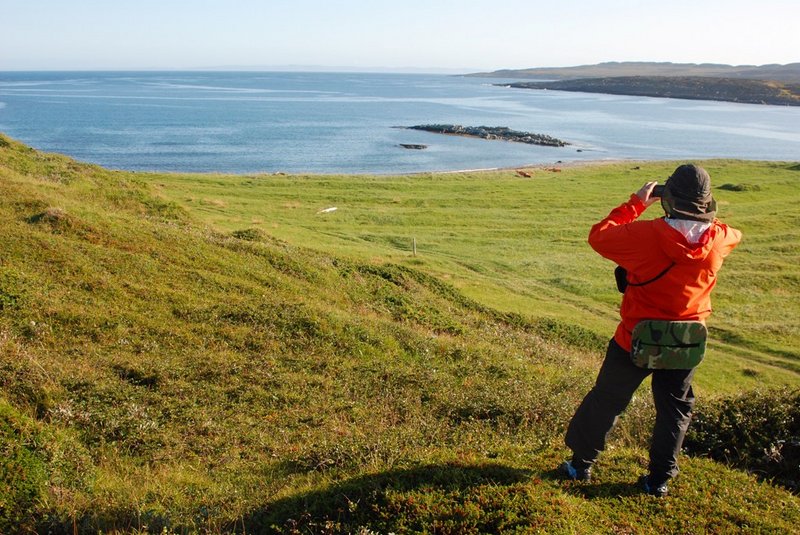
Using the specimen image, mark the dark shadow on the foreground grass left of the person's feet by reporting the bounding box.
[237,463,533,533]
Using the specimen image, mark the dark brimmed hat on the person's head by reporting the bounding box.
[661,164,717,221]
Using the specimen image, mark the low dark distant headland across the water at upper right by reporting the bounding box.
[467,62,800,106]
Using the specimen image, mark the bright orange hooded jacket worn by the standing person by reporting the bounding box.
[589,194,742,350]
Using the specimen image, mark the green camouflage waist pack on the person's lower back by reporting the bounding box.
[631,320,708,370]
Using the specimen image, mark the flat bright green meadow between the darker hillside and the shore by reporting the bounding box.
[147,161,800,392]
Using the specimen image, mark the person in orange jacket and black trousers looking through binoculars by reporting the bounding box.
[562,164,742,497]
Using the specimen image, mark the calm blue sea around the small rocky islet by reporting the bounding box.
[0,72,800,173]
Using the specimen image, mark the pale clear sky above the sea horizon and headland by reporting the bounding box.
[0,0,800,72]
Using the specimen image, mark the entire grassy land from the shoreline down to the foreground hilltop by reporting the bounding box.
[0,135,800,534]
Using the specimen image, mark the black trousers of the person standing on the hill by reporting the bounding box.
[566,339,694,484]
